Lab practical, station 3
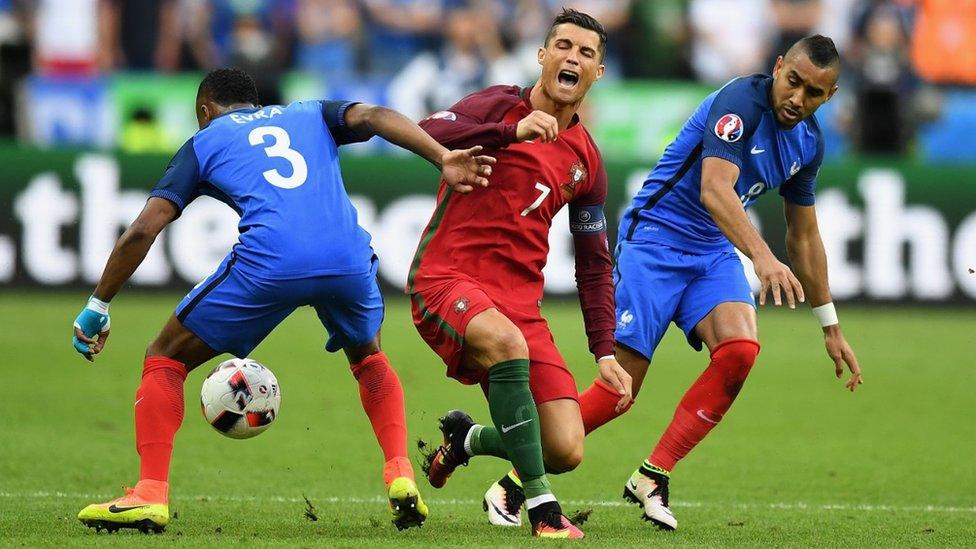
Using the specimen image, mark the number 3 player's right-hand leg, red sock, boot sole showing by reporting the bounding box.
[343,333,429,530]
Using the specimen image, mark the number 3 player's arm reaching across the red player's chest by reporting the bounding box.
[345,103,495,192]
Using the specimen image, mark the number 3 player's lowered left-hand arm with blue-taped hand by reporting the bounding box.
[73,197,179,361]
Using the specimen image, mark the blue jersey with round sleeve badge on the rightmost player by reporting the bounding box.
[619,74,823,253]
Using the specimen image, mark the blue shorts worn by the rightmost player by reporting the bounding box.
[613,240,756,360]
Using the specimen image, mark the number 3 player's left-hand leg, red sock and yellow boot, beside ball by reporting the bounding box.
[78,315,217,532]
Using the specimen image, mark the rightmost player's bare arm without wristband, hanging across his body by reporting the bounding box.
[701,157,805,309]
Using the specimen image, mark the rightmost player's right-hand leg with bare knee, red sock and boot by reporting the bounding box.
[624,302,759,530]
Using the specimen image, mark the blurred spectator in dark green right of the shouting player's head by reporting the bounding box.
[611,0,692,79]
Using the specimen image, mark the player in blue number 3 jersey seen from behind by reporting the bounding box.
[74,69,494,531]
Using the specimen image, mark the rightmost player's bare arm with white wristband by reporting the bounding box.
[785,200,863,391]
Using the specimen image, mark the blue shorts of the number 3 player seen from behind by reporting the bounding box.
[176,252,383,358]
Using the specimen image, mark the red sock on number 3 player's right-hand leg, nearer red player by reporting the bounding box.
[351,352,414,484]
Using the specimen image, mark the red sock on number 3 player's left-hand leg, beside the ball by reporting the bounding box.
[135,356,186,482]
